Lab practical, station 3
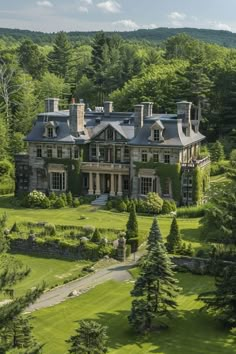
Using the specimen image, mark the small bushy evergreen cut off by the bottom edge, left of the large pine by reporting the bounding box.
[67,320,108,354]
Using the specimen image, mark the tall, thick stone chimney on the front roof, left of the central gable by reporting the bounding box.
[69,100,85,134]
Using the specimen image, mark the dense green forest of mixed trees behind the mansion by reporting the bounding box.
[0,32,236,164]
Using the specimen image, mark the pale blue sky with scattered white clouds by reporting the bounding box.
[0,0,236,32]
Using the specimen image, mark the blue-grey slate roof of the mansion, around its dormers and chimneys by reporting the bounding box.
[25,110,205,147]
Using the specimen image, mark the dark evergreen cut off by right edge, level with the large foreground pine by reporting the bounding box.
[199,265,236,328]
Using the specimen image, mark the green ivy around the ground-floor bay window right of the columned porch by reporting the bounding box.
[135,161,181,202]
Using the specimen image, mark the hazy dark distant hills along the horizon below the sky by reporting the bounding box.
[0,27,236,48]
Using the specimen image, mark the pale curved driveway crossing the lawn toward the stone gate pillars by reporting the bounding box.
[26,262,136,312]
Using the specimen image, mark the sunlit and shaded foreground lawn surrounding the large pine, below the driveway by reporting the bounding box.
[32,274,236,354]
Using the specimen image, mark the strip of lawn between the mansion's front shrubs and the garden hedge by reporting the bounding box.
[0,196,200,248]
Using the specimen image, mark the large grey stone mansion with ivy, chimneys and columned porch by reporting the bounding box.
[16,98,209,204]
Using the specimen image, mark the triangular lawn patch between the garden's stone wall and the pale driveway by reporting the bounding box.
[0,255,91,296]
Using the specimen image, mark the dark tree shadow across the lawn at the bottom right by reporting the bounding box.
[80,310,236,354]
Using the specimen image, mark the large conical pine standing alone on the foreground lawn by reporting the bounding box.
[128,216,179,333]
